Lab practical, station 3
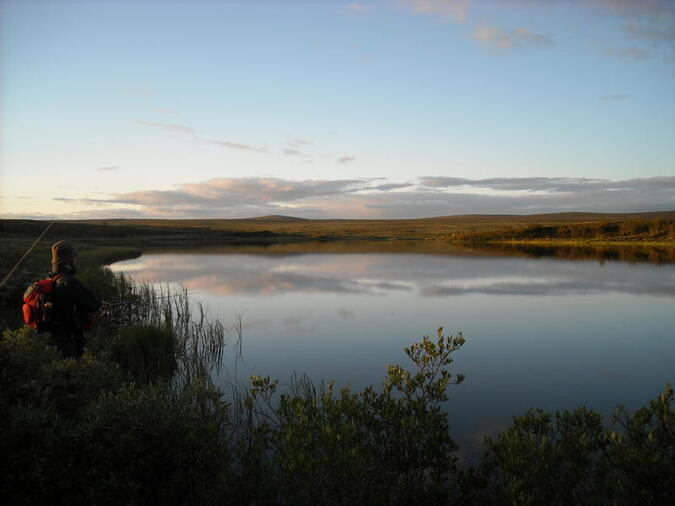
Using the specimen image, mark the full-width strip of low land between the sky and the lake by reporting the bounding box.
[0,211,675,247]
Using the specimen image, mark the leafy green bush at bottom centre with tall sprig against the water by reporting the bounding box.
[230,335,464,504]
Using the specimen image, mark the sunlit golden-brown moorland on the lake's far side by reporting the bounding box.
[73,211,675,245]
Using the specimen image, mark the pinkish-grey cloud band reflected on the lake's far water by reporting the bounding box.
[118,245,675,297]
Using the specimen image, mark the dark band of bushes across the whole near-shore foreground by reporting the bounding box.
[0,322,675,505]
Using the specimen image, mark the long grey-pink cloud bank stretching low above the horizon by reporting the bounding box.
[50,176,675,219]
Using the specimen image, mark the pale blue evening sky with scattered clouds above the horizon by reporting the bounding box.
[0,0,675,219]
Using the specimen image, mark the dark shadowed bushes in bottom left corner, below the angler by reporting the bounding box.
[0,330,228,505]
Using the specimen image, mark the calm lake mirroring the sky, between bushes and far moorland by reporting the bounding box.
[112,242,675,454]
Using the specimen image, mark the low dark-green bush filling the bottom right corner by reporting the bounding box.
[473,385,675,505]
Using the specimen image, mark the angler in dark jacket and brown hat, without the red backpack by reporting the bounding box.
[50,241,105,357]
